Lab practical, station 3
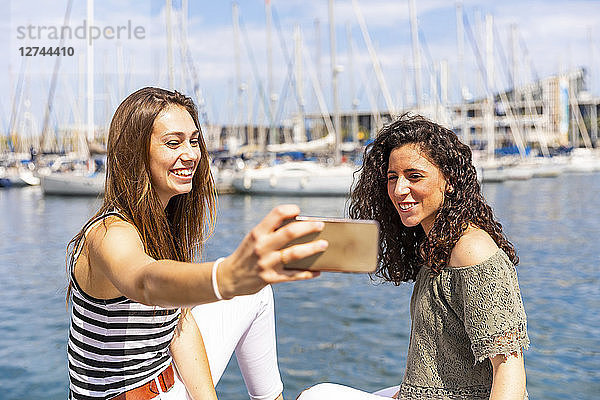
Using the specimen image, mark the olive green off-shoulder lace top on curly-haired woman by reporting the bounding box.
[399,250,529,400]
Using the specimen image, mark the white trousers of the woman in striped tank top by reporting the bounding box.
[192,286,283,400]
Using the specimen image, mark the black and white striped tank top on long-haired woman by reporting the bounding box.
[68,212,180,400]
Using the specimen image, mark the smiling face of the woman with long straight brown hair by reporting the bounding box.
[149,105,201,207]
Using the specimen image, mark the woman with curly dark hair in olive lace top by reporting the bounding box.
[300,114,529,400]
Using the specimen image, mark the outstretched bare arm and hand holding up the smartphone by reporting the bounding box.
[89,205,327,307]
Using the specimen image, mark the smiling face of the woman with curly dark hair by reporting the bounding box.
[387,144,447,234]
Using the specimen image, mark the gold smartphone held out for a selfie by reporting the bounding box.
[285,216,379,273]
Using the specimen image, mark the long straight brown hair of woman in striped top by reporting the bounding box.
[67,87,217,301]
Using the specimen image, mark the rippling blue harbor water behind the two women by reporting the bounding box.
[0,174,600,400]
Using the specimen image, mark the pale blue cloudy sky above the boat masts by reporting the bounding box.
[0,0,600,136]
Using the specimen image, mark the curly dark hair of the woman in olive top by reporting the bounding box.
[349,114,519,285]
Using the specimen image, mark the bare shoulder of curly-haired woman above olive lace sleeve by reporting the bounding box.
[449,226,498,267]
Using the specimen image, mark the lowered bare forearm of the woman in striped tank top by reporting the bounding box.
[169,310,217,400]
